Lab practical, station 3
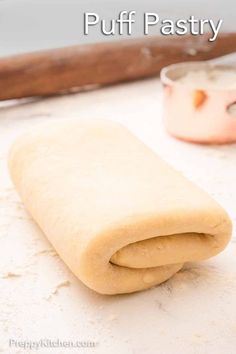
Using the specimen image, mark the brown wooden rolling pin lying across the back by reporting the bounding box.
[0,33,236,100]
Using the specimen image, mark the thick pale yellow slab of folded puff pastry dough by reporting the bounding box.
[9,120,231,294]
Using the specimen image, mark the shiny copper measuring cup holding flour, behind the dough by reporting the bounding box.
[161,62,236,144]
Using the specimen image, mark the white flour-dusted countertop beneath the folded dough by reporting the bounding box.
[0,79,236,354]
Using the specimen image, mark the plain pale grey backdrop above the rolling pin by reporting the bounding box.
[0,0,236,56]
